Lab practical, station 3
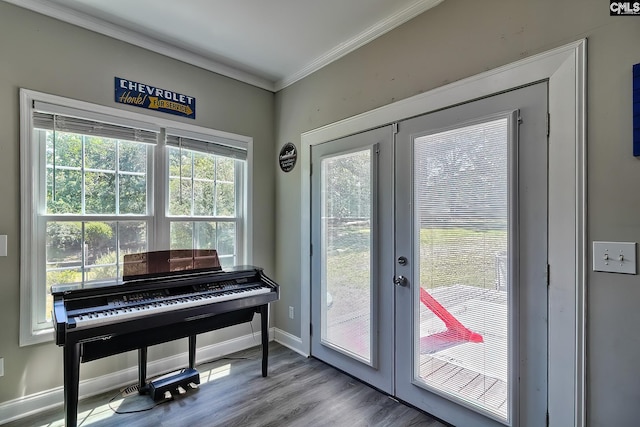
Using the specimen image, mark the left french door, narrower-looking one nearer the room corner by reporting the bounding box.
[311,126,395,394]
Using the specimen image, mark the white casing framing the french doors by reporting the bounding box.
[300,39,587,427]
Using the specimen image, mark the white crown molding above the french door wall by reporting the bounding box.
[274,0,444,92]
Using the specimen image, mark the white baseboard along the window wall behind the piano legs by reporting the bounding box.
[0,328,276,425]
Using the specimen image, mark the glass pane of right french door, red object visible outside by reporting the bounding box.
[414,117,510,421]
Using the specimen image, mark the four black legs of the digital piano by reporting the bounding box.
[63,304,269,427]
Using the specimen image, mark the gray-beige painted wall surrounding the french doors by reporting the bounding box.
[275,0,640,426]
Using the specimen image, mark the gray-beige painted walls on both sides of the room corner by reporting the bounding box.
[0,0,640,426]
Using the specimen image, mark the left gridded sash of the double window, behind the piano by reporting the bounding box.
[40,129,154,327]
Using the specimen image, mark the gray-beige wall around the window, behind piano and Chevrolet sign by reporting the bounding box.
[0,2,277,404]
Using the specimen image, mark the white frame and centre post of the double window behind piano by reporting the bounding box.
[20,89,253,346]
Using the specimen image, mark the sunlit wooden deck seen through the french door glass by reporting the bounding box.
[327,285,508,418]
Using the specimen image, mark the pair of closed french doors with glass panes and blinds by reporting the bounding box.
[311,83,547,426]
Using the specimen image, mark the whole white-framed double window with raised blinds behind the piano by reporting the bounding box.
[20,89,250,345]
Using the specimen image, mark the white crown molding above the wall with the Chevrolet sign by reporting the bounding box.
[3,0,274,92]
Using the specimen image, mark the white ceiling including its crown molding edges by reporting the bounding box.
[4,0,443,91]
